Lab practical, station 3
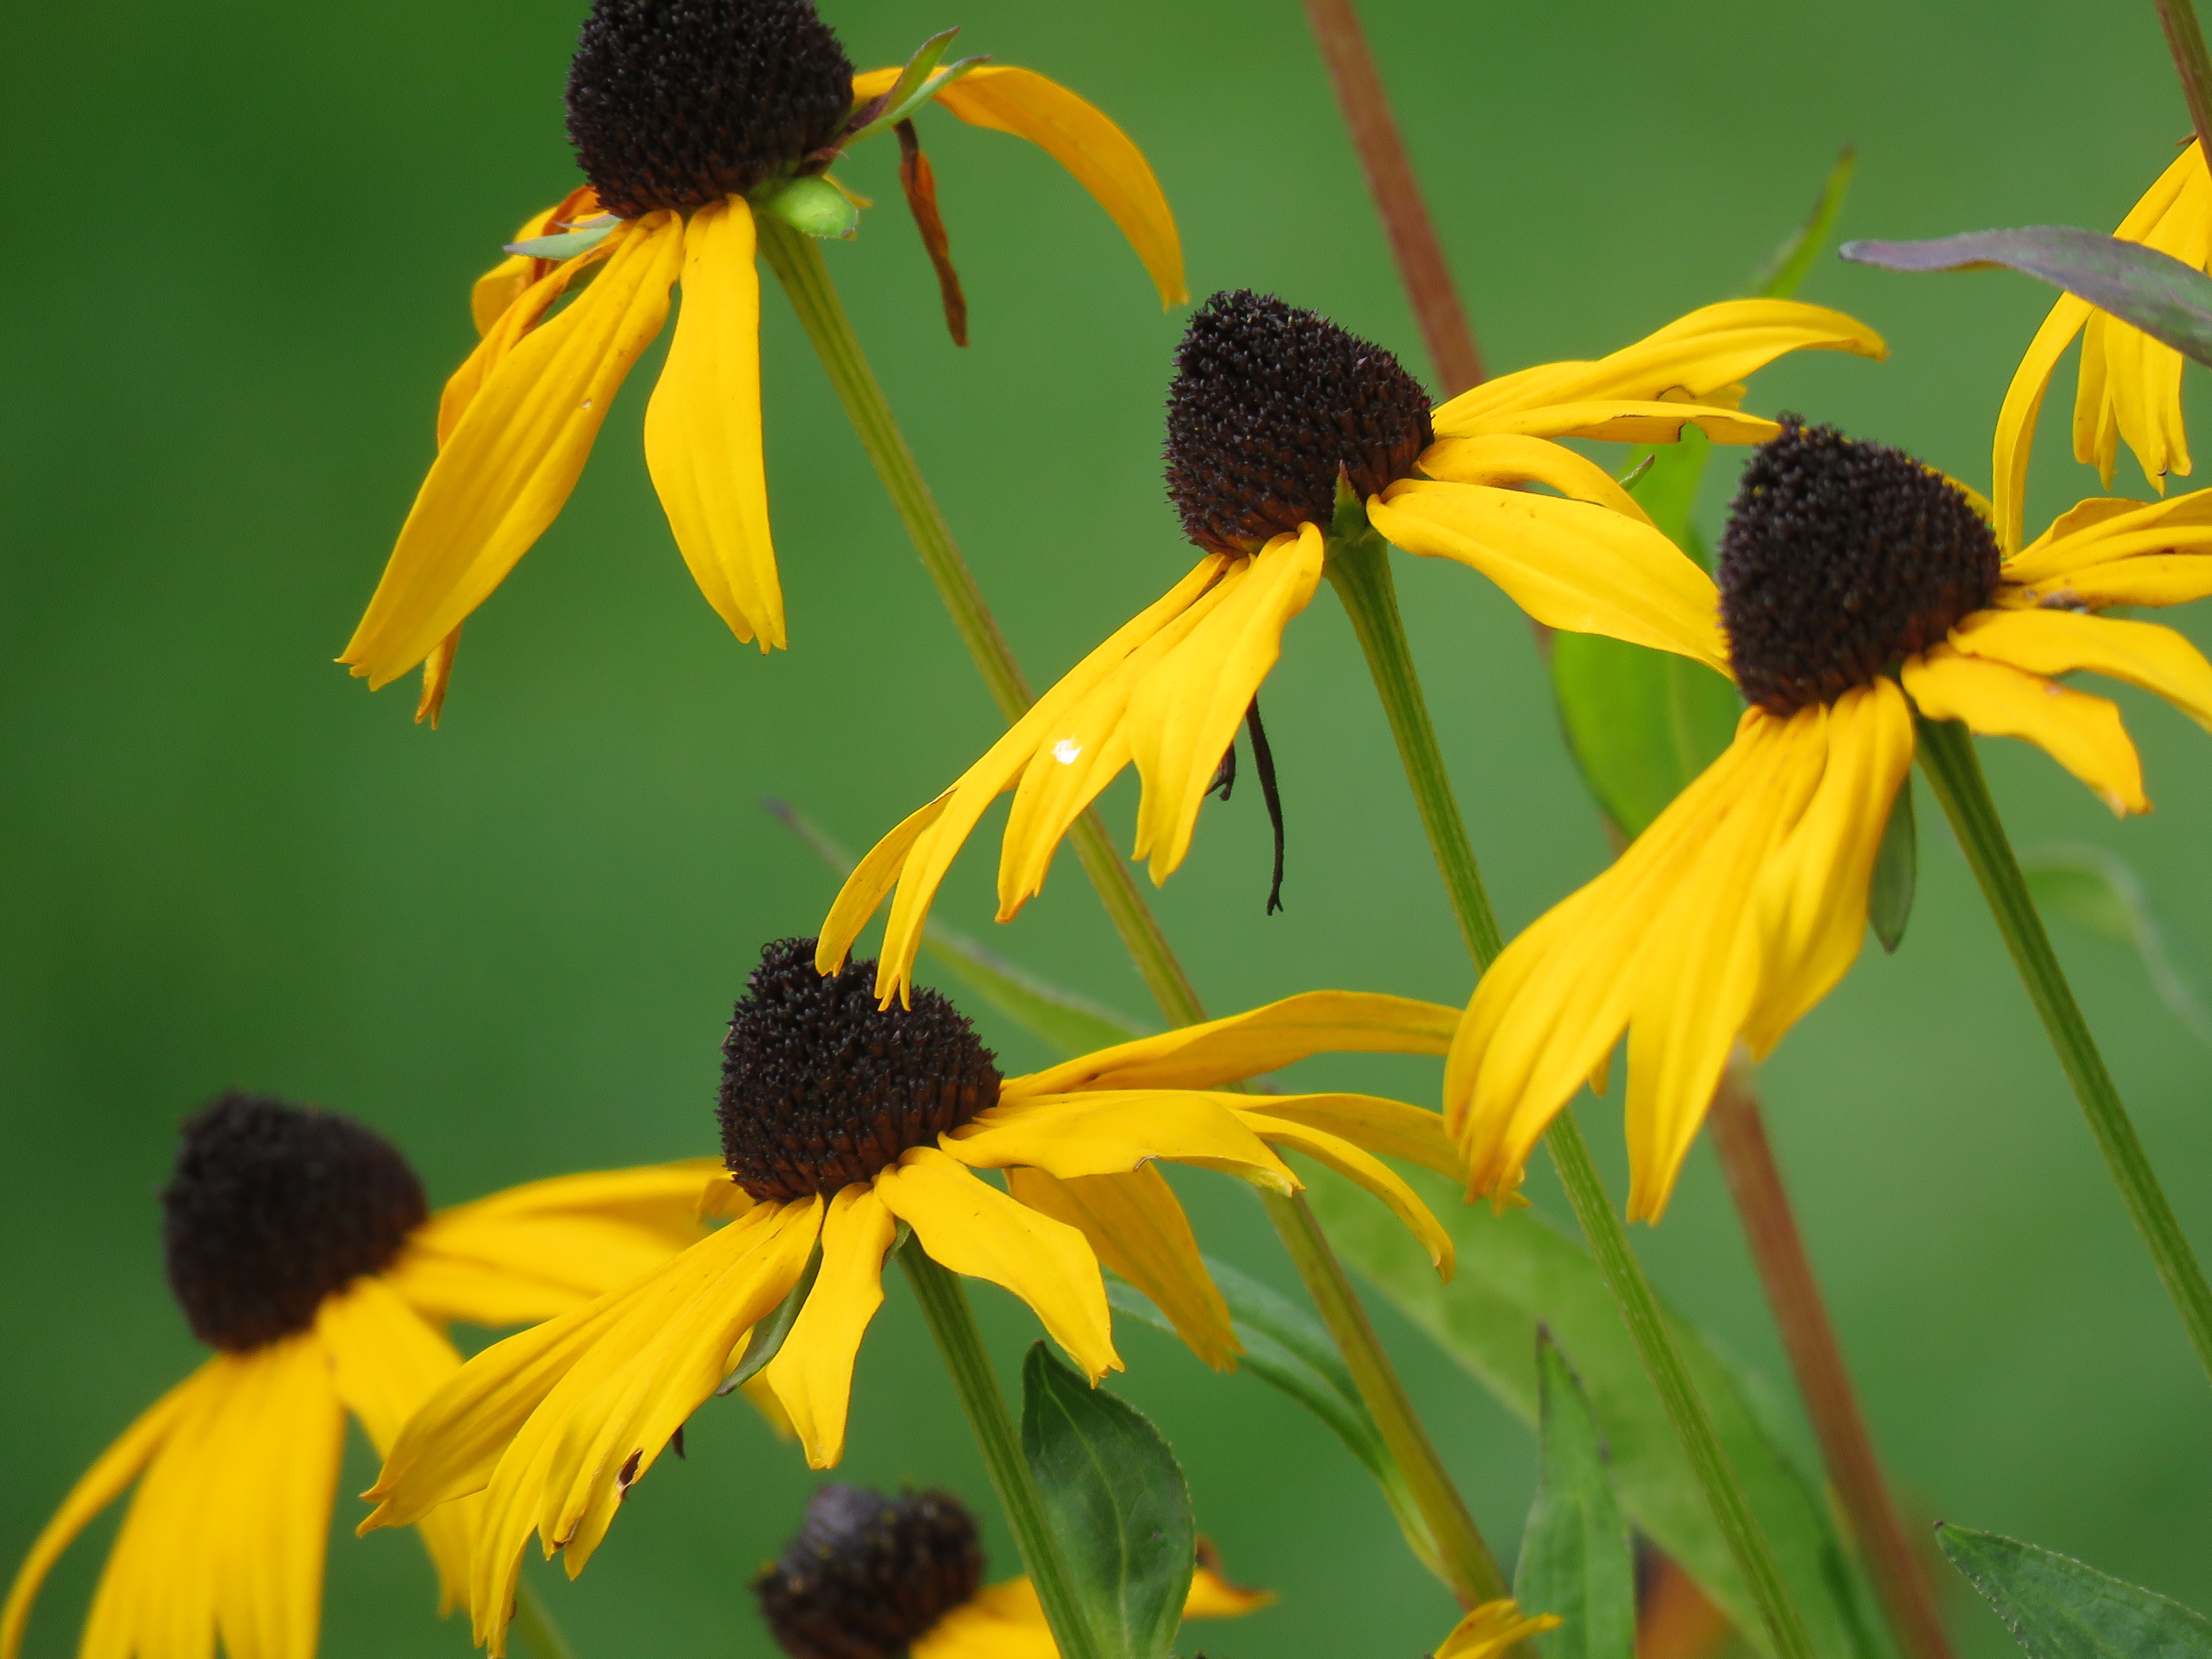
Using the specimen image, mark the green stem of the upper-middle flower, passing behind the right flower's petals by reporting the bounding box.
[1327,527,1812,1659]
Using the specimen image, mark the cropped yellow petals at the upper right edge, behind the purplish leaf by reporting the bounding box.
[1991,139,2212,546]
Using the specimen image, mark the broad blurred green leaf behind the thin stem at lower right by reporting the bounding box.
[1307,1170,1887,1659]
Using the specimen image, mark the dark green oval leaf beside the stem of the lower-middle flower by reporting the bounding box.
[1022,1343,1199,1659]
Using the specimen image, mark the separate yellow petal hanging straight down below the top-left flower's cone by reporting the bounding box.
[646,197,783,650]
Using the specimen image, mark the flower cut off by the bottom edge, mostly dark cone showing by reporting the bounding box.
[752,1484,1274,1659]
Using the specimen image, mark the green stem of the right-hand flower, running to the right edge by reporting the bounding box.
[1918,719,2212,1376]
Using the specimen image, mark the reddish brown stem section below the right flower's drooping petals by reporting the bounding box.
[1707,1066,1951,1659]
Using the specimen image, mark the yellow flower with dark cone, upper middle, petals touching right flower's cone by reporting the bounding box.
[821,292,1885,998]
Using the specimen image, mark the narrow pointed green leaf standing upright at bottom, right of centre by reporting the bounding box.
[1513,1325,1637,1659]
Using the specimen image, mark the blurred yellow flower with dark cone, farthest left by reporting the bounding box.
[0,1095,701,1659]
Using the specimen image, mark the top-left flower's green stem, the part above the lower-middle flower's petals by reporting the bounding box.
[754,215,1205,1024]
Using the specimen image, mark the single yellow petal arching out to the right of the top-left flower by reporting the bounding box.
[925,64,1190,310]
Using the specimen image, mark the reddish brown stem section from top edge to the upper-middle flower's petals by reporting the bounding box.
[1305,0,1484,396]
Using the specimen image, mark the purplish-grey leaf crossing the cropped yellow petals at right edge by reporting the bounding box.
[1838,226,2212,363]
